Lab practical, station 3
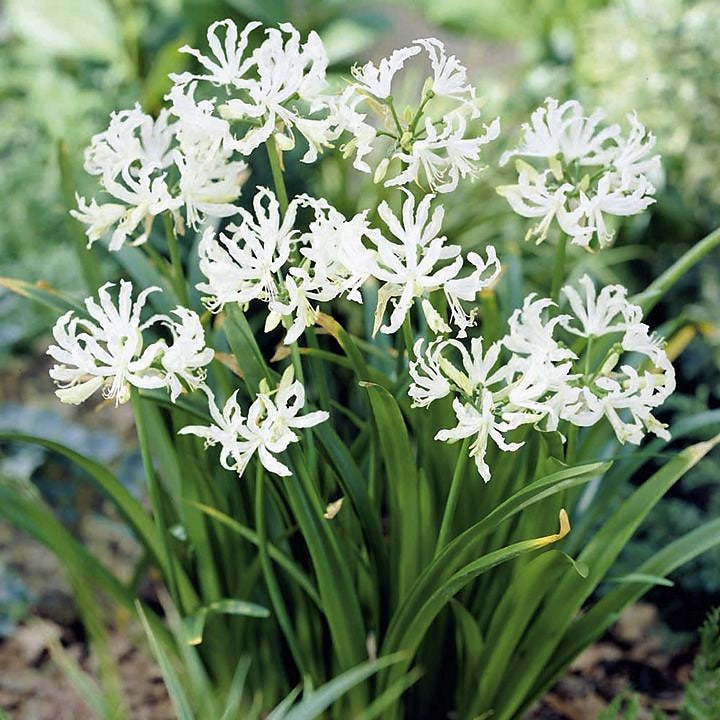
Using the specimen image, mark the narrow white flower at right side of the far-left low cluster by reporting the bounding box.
[161,307,215,402]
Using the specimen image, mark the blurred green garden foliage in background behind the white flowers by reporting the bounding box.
[0,0,720,660]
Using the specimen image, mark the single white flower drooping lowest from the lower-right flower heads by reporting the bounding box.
[435,390,524,482]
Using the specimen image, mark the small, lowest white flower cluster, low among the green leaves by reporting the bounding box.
[180,367,329,476]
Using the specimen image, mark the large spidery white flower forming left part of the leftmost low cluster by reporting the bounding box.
[47,280,166,405]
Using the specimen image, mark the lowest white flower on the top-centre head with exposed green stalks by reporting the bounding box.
[385,113,500,193]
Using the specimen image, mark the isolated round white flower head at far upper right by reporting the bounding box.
[497,98,660,248]
